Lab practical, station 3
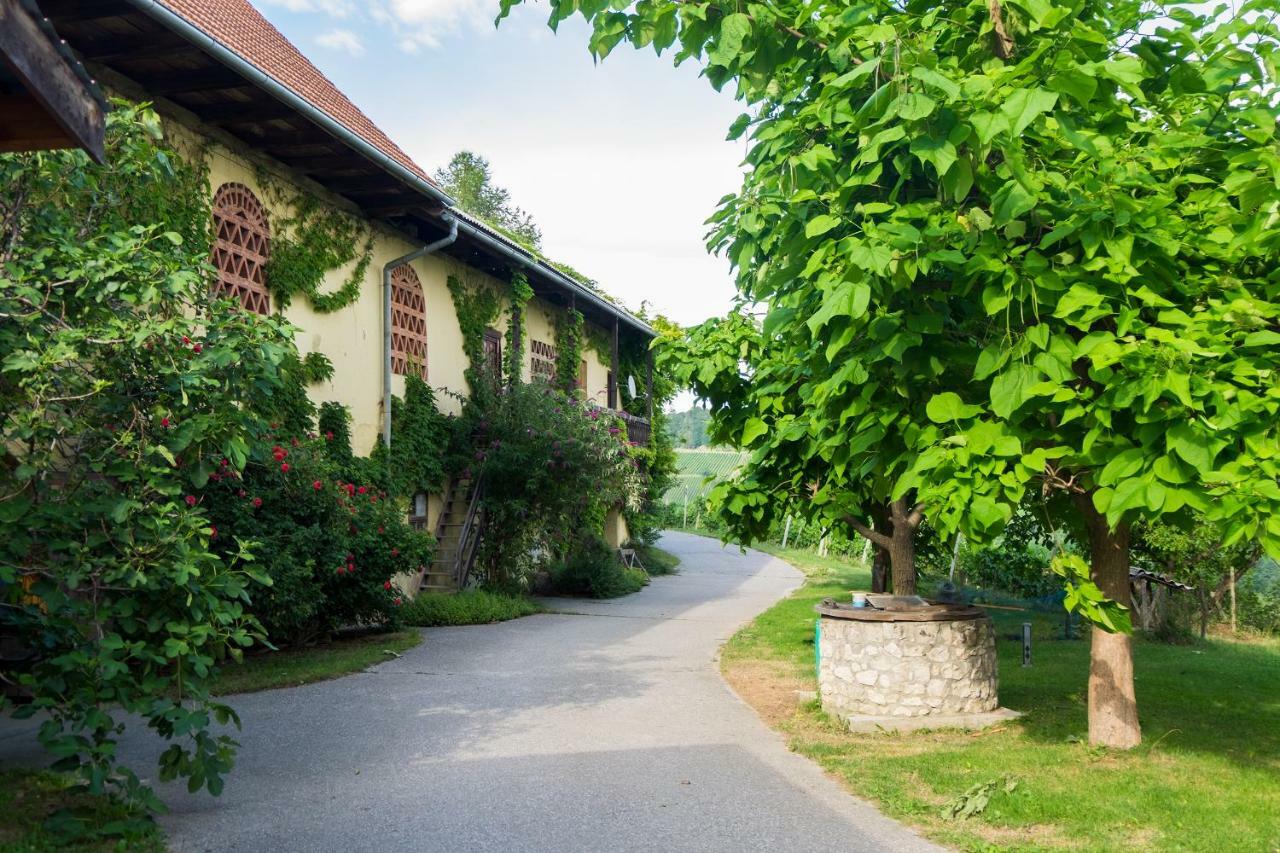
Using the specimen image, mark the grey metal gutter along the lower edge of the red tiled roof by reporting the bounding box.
[116,0,454,207]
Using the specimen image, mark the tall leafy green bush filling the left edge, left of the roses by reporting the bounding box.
[0,104,294,808]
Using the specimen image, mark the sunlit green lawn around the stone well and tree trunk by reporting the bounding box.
[722,540,1280,850]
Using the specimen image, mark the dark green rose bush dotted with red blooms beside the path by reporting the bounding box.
[198,420,431,643]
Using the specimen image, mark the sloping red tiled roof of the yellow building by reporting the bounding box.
[160,0,430,181]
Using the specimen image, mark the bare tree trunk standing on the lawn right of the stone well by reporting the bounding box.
[1079,494,1142,749]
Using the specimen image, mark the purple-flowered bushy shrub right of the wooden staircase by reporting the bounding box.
[456,383,641,587]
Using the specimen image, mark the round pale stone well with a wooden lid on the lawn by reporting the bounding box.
[817,599,1012,729]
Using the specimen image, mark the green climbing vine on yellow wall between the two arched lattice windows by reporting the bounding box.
[255,168,374,314]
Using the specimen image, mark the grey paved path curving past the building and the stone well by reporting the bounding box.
[0,534,934,853]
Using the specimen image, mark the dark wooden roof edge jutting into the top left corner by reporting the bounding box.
[0,0,106,163]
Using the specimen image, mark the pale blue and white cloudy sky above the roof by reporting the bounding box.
[253,0,745,324]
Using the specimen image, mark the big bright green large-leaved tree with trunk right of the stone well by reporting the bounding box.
[503,0,1280,748]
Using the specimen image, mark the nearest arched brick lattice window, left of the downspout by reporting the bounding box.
[212,183,271,314]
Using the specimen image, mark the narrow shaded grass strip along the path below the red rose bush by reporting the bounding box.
[210,630,422,695]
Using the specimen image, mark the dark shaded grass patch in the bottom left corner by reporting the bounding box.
[0,770,165,853]
